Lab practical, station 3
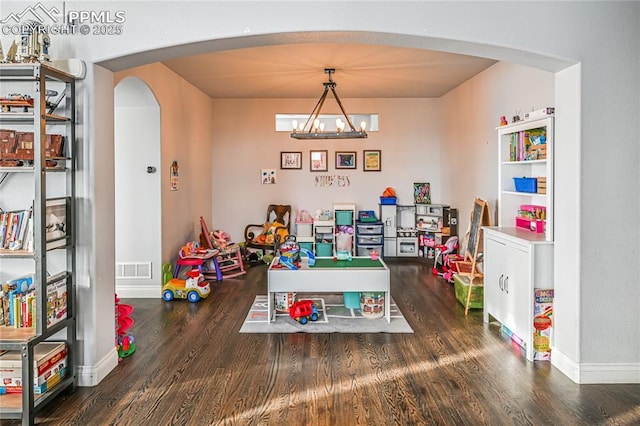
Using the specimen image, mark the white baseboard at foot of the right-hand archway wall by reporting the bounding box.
[551,348,640,384]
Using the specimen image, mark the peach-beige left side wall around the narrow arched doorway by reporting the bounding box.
[115,63,214,266]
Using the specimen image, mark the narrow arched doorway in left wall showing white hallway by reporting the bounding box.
[114,77,162,297]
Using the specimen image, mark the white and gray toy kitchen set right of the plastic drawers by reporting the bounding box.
[380,203,458,259]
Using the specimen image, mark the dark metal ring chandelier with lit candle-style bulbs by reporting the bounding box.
[291,68,367,139]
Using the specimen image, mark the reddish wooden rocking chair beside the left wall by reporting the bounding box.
[200,216,247,281]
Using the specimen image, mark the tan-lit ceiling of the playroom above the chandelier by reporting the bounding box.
[163,43,496,98]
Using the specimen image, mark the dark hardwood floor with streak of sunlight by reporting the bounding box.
[7,259,640,426]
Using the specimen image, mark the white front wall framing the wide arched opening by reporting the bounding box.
[3,1,640,382]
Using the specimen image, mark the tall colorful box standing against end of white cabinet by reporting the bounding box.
[533,288,553,361]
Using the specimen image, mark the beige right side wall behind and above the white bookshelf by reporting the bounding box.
[441,62,555,238]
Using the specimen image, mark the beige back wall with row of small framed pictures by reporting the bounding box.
[210,98,440,240]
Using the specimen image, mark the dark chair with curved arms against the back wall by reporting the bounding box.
[244,204,291,256]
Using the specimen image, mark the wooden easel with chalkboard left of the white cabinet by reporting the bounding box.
[455,198,491,315]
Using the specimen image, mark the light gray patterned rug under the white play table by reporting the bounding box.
[240,294,413,333]
